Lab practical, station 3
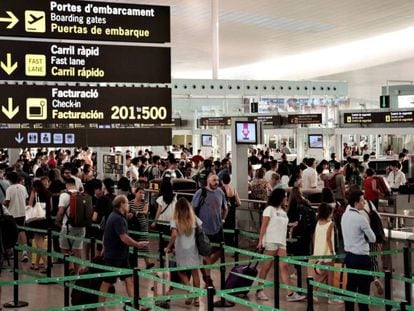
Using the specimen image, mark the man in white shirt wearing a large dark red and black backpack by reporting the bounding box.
[56,178,93,274]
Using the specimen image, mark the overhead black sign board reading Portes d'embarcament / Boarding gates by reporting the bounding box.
[0,0,170,43]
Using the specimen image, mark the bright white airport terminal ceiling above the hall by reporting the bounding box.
[110,0,414,101]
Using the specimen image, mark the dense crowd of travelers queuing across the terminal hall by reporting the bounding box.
[0,148,406,310]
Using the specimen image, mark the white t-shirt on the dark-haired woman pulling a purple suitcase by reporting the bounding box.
[263,205,289,246]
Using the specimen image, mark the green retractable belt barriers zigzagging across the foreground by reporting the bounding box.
[5,221,414,311]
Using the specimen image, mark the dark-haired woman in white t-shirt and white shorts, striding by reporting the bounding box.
[256,189,306,301]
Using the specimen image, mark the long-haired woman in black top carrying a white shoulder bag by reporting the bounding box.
[27,180,52,273]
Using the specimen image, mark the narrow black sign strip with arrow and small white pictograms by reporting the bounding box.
[1,128,172,148]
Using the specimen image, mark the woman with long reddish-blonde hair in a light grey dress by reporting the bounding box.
[165,198,202,307]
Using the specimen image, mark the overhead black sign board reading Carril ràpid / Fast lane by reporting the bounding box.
[0,40,171,83]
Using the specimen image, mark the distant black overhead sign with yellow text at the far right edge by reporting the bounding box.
[344,111,414,124]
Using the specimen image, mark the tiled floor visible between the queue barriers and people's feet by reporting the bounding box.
[1,251,404,311]
